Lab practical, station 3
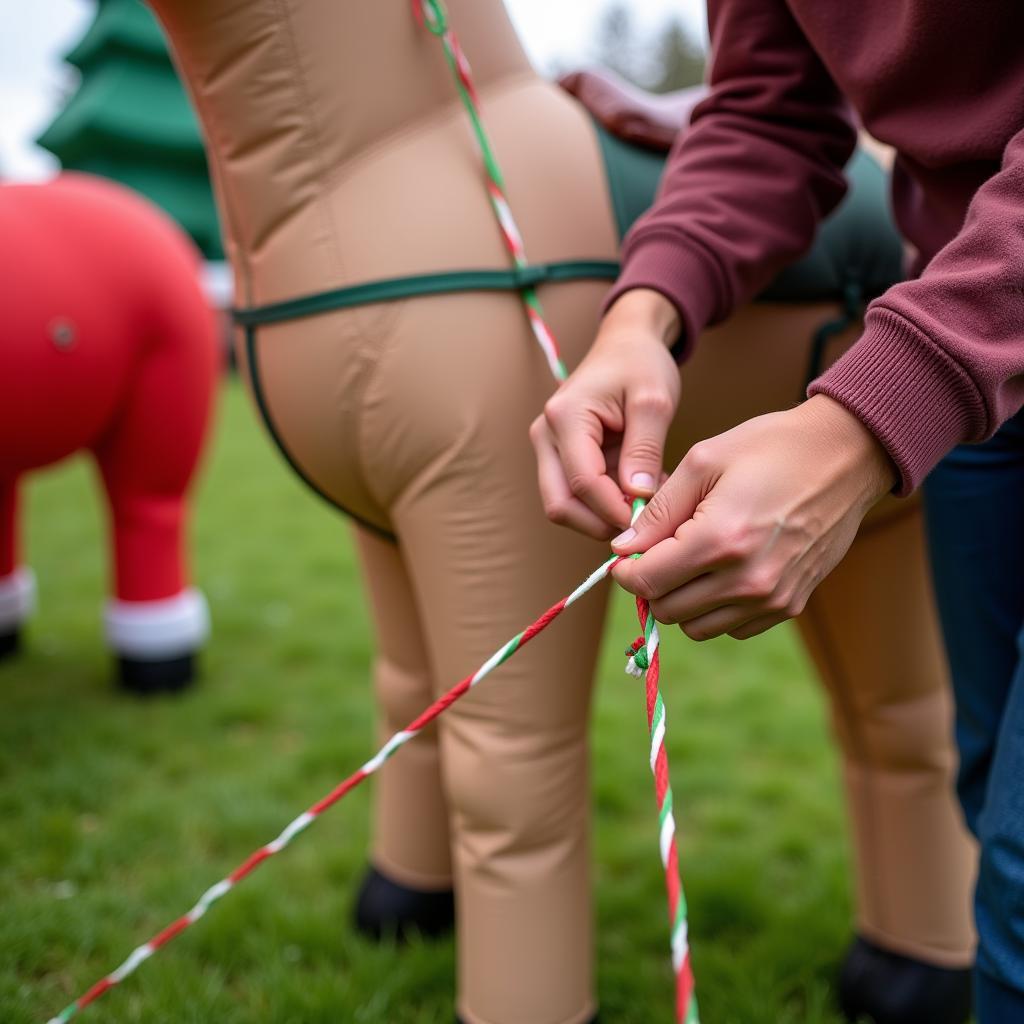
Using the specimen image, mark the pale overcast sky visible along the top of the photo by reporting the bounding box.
[0,0,705,180]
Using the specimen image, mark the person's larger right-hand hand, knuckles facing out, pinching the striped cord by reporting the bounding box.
[612,395,896,640]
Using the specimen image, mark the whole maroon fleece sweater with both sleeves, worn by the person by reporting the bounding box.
[609,0,1024,493]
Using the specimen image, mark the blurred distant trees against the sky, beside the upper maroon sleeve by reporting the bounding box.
[594,0,705,92]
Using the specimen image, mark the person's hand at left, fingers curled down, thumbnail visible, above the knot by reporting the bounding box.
[529,289,680,541]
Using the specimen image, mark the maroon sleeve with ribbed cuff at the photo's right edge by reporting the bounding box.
[809,130,1024,494]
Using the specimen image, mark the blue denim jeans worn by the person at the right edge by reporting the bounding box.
[925,403,1024,1024]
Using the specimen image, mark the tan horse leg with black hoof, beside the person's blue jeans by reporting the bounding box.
[800,506,975,1024]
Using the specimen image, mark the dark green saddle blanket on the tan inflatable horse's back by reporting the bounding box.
[595,125,902,302]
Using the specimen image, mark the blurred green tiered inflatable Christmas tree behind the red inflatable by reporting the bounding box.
[39,0,223,259]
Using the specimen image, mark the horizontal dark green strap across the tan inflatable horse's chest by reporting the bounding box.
[232,260,618,327]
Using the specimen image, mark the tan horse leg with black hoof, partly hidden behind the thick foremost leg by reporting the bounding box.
[354,528,455,936]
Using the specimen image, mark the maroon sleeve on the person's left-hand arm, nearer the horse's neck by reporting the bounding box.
[605,0,856,354]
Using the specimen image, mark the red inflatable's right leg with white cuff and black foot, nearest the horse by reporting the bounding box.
[94,256,217,689]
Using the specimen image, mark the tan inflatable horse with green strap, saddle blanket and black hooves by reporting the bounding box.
[154,0,972,1024]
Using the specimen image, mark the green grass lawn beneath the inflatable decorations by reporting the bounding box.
[0,383,850,1024]
